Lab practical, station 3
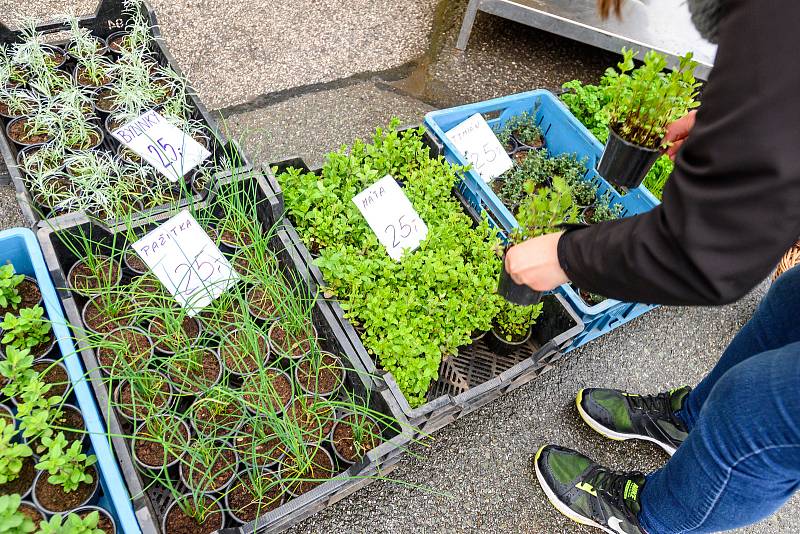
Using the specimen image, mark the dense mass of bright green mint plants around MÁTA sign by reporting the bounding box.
[278,121,500,406]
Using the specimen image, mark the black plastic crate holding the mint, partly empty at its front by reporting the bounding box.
[265,134,583,434]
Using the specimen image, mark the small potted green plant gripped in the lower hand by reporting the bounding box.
[497,176,578,306]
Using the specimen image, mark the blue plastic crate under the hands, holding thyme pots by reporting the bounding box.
[425,89,659,349]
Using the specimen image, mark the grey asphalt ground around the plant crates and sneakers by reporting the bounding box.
[0,0,800,534]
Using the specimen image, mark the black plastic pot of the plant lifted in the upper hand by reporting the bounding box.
[597,128,661,189]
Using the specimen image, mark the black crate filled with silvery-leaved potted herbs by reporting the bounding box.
[0,0,249,226]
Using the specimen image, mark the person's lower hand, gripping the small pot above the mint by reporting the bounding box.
[506,232,569,291]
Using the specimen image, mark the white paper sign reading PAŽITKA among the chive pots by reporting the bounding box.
[133,210,239,316]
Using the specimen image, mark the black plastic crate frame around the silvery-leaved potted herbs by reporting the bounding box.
[0,0,252,227]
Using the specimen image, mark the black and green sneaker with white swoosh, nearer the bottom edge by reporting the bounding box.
[533,445,645,534]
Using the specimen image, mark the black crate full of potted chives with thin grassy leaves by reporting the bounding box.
[39,173,414,533]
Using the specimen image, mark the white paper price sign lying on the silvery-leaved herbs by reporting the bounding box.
[112,111,211,182]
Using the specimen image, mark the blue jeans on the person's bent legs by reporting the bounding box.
[639,267,800,534]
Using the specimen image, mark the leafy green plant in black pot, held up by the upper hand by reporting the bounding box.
[597,48,700,188]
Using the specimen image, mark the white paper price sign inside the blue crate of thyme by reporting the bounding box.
[445,113,514,183]
